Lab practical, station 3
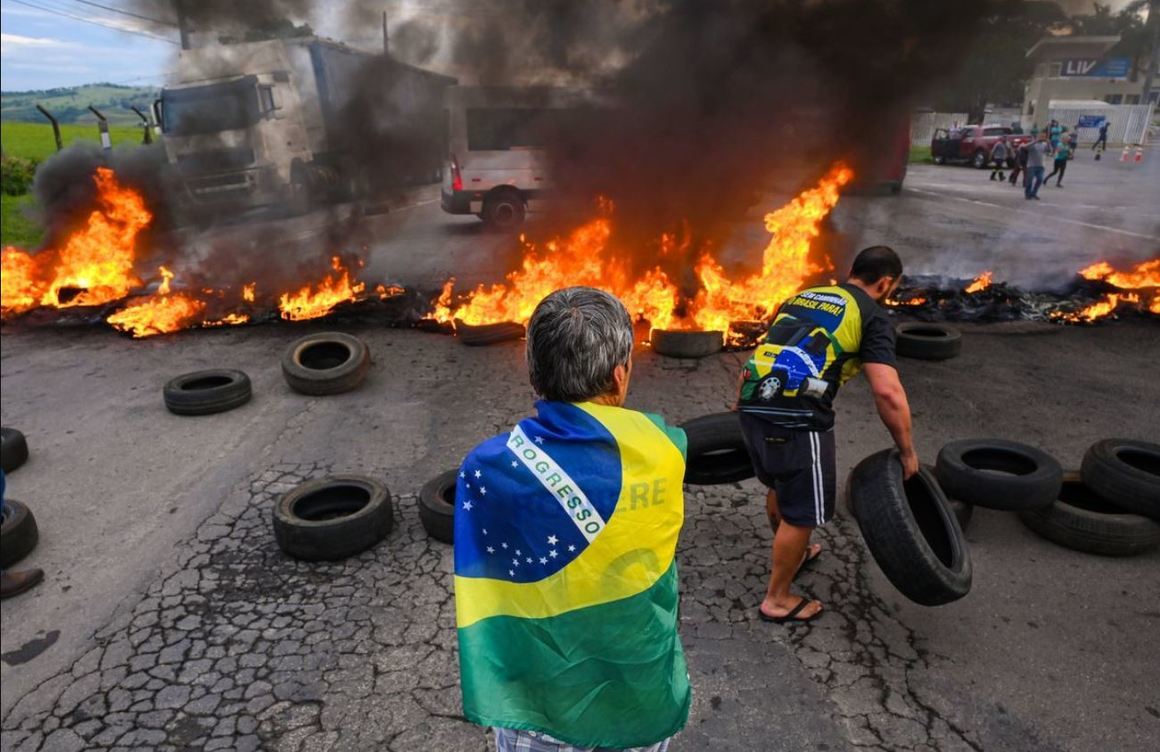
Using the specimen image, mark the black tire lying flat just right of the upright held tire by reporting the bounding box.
[935,439,1064,512]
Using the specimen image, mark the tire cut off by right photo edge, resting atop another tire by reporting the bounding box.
[1080,439,1160,520]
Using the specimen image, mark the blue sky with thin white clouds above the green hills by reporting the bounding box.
[0,0,1146,92]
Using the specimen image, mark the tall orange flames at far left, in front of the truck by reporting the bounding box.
[0,167,153,313]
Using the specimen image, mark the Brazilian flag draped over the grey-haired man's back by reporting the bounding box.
[455,402,691,747]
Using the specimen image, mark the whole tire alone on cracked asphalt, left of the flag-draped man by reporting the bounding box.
[274,475,394,562]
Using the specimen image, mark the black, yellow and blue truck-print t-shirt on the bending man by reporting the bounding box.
[740,284,896,431]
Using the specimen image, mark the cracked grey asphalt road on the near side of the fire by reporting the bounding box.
[0,323,1160,752]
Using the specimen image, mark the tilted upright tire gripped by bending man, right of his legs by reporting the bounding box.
[850,449,973,606]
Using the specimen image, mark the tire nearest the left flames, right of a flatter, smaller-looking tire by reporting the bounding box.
[282,332,370,396]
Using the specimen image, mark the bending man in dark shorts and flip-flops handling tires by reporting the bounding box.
[738,246,919,623]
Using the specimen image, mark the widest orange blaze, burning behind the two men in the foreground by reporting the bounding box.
[433,165,854,331]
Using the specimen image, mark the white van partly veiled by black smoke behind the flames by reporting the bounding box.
[440,86,593,230]
